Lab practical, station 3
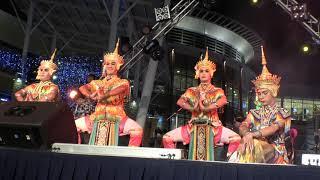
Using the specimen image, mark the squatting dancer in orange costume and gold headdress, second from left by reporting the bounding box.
[80,41,143,146]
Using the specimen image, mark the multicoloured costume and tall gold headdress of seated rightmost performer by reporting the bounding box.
[234,47,291,164]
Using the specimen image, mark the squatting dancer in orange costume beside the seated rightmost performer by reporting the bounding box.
[163,48,240,160]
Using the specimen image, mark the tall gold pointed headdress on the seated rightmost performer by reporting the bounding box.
[252,46,281,97]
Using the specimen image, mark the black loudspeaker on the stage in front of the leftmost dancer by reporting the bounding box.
[0,102,77,149]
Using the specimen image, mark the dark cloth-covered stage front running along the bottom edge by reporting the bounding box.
[0,147,320,180]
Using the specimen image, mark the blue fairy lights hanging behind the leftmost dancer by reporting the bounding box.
[0,49,101,98]
